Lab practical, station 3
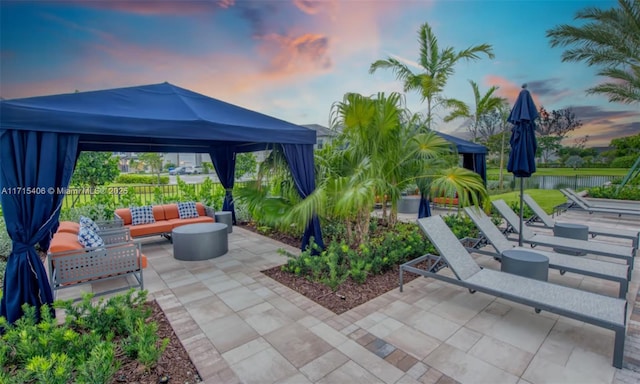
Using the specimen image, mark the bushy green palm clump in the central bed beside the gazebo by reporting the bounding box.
[236,93,486,245]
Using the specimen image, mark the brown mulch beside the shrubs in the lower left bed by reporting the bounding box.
[114,301,201,384]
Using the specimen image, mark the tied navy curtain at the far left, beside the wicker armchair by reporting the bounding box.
[0,130,78,323]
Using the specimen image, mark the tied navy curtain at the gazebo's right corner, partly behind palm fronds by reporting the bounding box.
[282,144,324,250]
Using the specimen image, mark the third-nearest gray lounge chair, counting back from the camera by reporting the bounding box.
[491,200,635,270]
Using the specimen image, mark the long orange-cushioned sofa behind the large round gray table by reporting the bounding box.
[115,203,216,239]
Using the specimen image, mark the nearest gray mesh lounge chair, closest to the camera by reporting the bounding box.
[400,216,627,368]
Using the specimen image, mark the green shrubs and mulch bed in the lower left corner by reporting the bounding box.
[0,290,199,384]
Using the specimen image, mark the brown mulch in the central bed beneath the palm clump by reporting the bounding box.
[240,223,418,314]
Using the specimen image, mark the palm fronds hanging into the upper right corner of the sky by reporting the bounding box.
[547,0,640,104]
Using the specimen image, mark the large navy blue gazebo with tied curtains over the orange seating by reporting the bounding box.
[0,83,322,323]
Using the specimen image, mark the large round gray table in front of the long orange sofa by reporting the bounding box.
[171,223,229,261]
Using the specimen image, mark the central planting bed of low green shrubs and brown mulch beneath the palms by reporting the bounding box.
[258,214,478,314]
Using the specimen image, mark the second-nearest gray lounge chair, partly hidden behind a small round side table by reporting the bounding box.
[464,207,629,299]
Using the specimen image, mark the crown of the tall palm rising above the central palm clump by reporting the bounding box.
[369,23,494,129]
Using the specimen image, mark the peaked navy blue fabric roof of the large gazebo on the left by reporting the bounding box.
[0,83,316,152]
